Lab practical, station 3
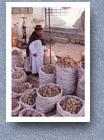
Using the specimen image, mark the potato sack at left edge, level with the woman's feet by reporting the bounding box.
[12,70,28,86]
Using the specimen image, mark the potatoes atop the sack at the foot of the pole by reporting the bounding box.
[41,65,55,74]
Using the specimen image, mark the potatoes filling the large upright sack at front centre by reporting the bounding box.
[38,84,61,97]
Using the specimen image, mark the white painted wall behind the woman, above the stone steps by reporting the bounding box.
[12,8,84,37]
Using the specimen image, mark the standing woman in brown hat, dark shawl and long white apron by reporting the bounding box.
[26,25,47,74]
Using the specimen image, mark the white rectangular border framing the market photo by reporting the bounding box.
[6,2,90,122]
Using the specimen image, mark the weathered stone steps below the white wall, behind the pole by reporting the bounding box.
[42,27,85,44]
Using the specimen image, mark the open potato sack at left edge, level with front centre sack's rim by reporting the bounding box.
[12,82,32,98]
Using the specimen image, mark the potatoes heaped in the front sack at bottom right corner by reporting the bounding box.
[60,97,82,114]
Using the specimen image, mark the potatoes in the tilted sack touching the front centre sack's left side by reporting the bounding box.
[21,89,37,105]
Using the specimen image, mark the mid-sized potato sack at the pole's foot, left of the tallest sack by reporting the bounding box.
[39,65,55,86]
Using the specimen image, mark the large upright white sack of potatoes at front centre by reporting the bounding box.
[36,83,63,113]
